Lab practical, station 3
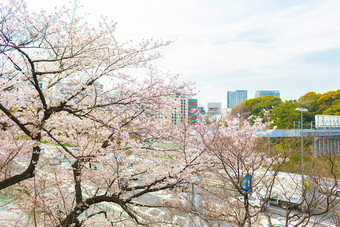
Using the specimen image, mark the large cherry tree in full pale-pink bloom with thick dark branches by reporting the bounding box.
[0,0,200,226]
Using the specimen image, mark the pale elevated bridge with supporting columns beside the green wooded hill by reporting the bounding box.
[267,129,340,156]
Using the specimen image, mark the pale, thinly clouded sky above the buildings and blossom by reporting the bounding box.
[27,0,340,108]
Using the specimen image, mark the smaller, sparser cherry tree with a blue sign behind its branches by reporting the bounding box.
[167,116,287,226]
